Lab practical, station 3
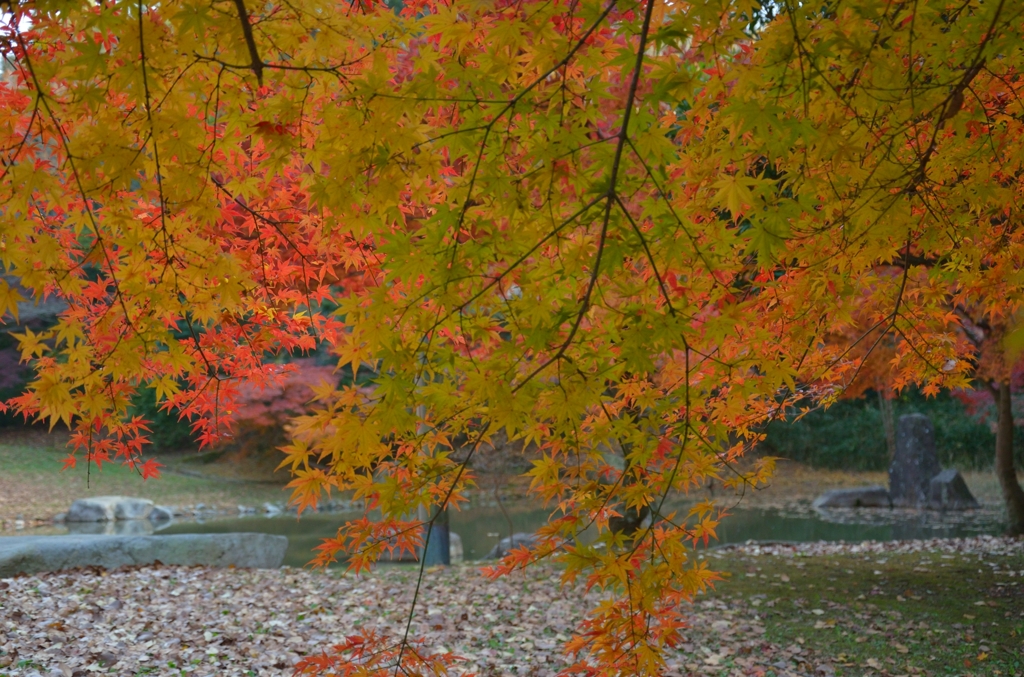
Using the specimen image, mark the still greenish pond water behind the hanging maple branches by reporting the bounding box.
[142,505,1004,566]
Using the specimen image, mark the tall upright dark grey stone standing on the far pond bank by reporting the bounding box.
[889,414,942,508]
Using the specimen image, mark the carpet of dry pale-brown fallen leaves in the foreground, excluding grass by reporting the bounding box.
[0,566,775,676]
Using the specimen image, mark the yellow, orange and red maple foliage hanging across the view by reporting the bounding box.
[0,0,1024,674]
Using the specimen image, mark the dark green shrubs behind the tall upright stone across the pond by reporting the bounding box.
[761,389,1024,470]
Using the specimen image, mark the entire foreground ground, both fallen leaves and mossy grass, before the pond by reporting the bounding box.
[0,539,1024,677]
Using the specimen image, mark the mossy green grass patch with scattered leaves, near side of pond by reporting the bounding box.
[713,553,1024,675]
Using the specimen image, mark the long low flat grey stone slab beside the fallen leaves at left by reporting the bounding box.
[0,534,288,578]
